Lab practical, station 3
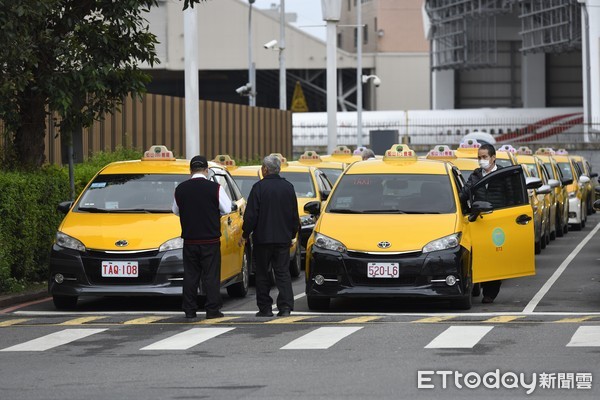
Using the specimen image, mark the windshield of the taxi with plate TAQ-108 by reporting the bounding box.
[76,174,190,213]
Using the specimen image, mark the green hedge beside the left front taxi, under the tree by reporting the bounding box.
[0,149,142,293]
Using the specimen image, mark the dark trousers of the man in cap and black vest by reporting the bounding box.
[182,243,223,312]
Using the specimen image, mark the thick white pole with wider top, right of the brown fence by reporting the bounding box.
[321,0,342,154]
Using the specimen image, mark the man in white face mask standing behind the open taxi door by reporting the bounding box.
[460,143,512,304]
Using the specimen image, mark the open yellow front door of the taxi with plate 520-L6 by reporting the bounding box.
[465,165,535,282]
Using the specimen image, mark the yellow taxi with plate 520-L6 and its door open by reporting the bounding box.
[305,144,539,309]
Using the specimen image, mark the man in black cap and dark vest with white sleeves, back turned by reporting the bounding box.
[173,156,231,319]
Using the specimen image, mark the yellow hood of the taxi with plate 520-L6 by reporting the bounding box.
[316,213,457,252]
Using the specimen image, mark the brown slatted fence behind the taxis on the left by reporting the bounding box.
[0,94,292,165]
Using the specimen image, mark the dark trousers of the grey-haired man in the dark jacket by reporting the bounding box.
[254,244,294,311]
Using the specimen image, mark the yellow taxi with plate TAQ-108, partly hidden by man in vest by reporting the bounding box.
[48,146,249,309]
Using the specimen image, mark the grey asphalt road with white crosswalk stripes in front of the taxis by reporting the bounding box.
[0,214,600,399]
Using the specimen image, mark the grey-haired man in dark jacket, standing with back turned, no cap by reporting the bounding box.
[240,156,300,317]
